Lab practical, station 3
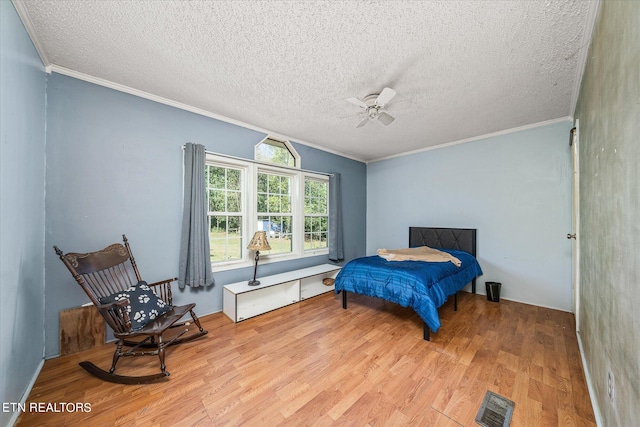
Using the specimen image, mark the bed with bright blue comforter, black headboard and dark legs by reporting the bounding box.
[335,227,482,341]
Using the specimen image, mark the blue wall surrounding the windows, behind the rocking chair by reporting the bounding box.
[45,74,366,356]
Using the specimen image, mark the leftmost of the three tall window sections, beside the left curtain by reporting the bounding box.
[206,163,246,263]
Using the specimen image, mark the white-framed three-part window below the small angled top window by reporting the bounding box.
[206,153,329,270]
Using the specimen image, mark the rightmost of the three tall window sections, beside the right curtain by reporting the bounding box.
[304,177,329,251]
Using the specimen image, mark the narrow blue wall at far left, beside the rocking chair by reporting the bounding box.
[0,1,46,425]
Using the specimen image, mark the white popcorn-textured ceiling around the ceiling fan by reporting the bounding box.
[14,0,597,161]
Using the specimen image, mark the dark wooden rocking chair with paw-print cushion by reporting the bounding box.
[53,234,207,384]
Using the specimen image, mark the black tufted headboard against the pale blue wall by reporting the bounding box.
[409,227,476,256]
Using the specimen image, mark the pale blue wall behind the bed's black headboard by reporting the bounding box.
[367,122,572,311]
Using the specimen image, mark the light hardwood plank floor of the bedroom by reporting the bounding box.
[17,293,595,427]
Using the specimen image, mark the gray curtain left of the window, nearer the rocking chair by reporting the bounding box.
[178,142,214,288]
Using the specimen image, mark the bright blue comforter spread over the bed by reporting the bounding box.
[335,249,482,332]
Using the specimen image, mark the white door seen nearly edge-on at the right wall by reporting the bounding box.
[567,120,580,332]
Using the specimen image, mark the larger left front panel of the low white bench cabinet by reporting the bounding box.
[236,280,300,322]
